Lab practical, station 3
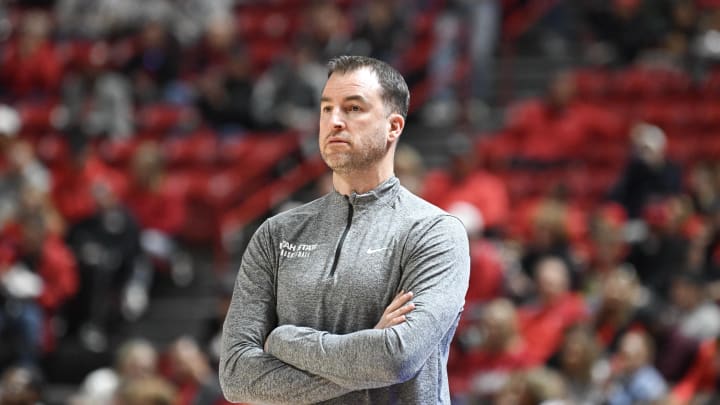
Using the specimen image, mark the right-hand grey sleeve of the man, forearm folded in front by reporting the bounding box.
[267,215,470,390]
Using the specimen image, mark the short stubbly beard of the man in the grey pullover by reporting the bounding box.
[320,131,388,174]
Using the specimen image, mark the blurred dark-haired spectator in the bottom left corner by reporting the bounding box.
[0,366,44,405]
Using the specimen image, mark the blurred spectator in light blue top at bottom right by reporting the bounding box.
[607,331,668,405]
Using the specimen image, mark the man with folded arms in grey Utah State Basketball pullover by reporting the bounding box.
[220,56,469,404]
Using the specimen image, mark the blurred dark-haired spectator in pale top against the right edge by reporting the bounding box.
[670,272,720,341]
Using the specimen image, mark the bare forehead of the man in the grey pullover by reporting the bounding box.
[322,67,381,101]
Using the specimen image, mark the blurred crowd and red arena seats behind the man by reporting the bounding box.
[0,0,720,405]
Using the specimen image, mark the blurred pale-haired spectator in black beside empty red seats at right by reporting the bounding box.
[610,123,682,218]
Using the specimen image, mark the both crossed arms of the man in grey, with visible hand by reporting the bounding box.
[220,217,469,403]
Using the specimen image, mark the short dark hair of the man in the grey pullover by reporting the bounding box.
[328,55,410,118]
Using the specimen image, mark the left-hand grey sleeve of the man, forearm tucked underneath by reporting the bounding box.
[220,222,349,404]
